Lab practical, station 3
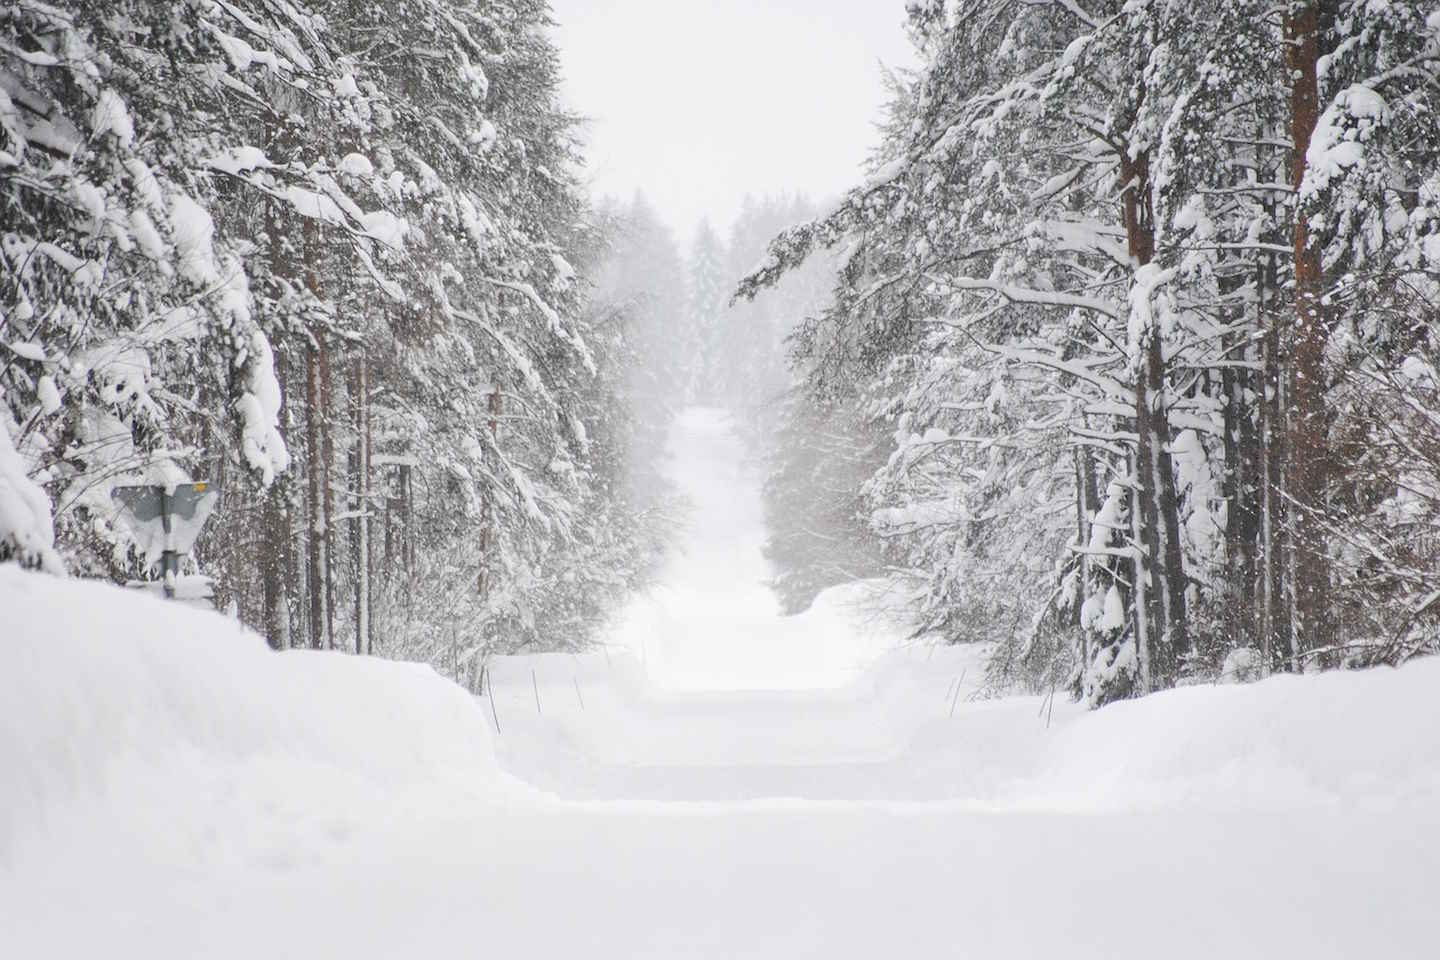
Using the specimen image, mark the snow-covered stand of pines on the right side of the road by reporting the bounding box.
[740,0,1440,705]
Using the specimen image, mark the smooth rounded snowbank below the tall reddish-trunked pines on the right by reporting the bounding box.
[1007,659,1440,812]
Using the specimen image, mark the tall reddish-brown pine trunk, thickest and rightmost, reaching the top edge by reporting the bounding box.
[1284,0,1333,656]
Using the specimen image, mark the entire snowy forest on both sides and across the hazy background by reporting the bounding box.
[0,0,1440,705]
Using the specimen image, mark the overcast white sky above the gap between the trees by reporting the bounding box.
[552,0,913,246]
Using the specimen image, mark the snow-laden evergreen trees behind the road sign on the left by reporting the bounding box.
[0,0,678,682]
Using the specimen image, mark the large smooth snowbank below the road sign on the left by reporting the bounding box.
[0,566,516,865]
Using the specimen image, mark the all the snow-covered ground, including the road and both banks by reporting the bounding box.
[0,413,1440,960]
